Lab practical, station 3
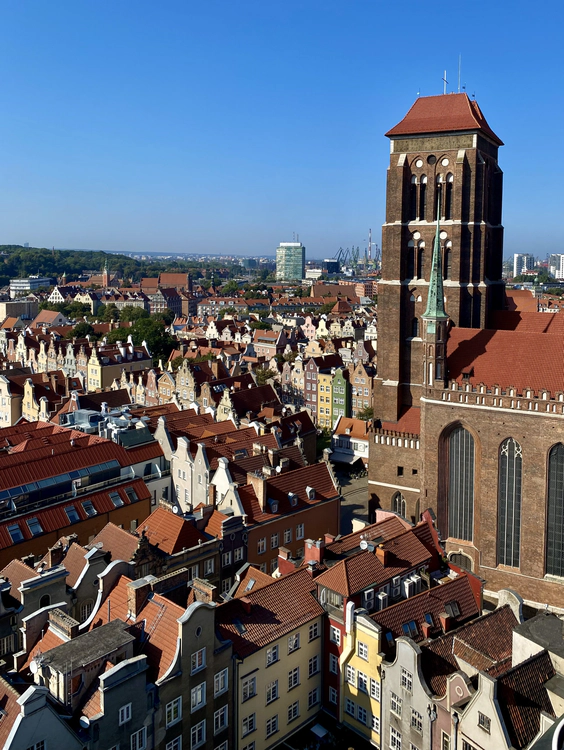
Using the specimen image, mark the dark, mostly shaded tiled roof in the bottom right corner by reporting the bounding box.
[497,651,555,748]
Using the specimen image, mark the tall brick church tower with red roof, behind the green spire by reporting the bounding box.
[374,94,504,423]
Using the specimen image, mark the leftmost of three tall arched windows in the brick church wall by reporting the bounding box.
[448,427,474,541]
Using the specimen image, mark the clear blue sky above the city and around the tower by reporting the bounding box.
[0,0,564,257]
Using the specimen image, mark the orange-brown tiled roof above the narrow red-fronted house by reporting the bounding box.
[316,529,431,601]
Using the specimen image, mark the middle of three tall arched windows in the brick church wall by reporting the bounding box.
[497,438,523,568]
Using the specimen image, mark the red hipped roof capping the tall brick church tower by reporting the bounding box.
[386,94,503,146]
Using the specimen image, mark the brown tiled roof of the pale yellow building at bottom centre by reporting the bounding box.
[216,568,324,658]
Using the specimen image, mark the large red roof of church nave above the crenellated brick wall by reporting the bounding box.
[447,328,564,397]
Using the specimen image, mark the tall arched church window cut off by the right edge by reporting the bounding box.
[546,443,564,576]
